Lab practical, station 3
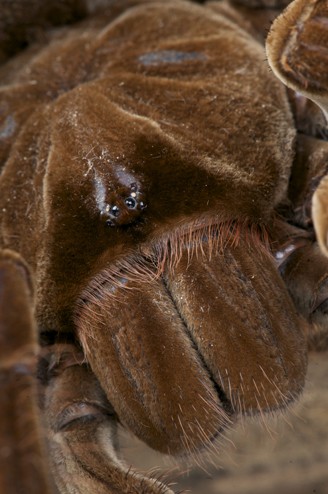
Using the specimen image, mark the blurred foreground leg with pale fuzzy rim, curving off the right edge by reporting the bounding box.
[267,0,328,255]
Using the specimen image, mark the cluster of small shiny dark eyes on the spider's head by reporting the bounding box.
[101,183,147,227]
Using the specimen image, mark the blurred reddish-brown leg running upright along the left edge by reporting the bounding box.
[0,250,55,494]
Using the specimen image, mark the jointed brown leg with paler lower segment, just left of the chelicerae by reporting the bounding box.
[39,344,173,494]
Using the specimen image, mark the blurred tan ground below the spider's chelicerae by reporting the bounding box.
[121,353,328,494]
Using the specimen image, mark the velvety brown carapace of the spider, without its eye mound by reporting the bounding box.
[1,2,294,329]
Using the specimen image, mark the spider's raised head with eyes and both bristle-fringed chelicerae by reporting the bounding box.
[25,88,306,460]
